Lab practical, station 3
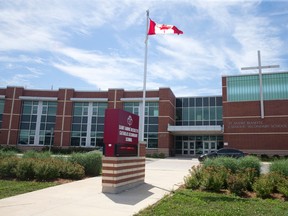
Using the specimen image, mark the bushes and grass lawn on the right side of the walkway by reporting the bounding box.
[136,156,288,216]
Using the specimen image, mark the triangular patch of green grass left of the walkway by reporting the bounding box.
[0,180,58,199]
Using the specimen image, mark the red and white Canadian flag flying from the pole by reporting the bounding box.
[148,19,183,35]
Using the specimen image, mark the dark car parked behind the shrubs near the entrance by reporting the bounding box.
[198,148,245,162]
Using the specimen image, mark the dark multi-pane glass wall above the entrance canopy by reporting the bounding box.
[176,96,223,126]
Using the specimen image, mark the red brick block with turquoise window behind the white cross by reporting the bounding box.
[222,73,288,155]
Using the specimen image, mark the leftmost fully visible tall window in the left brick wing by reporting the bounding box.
[18,101,57,145]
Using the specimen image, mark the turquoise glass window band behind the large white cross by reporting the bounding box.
[227,73,288,101]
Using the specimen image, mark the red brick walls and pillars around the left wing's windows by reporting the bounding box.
[0,87,175,155]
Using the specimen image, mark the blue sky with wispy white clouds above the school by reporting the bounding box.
[0,0,288,97]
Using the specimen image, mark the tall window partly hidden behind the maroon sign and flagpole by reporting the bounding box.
[124,102,159,148]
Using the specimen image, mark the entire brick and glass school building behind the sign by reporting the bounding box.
[0,72,288,156]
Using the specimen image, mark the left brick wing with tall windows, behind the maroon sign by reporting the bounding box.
[0,87,175,155]
